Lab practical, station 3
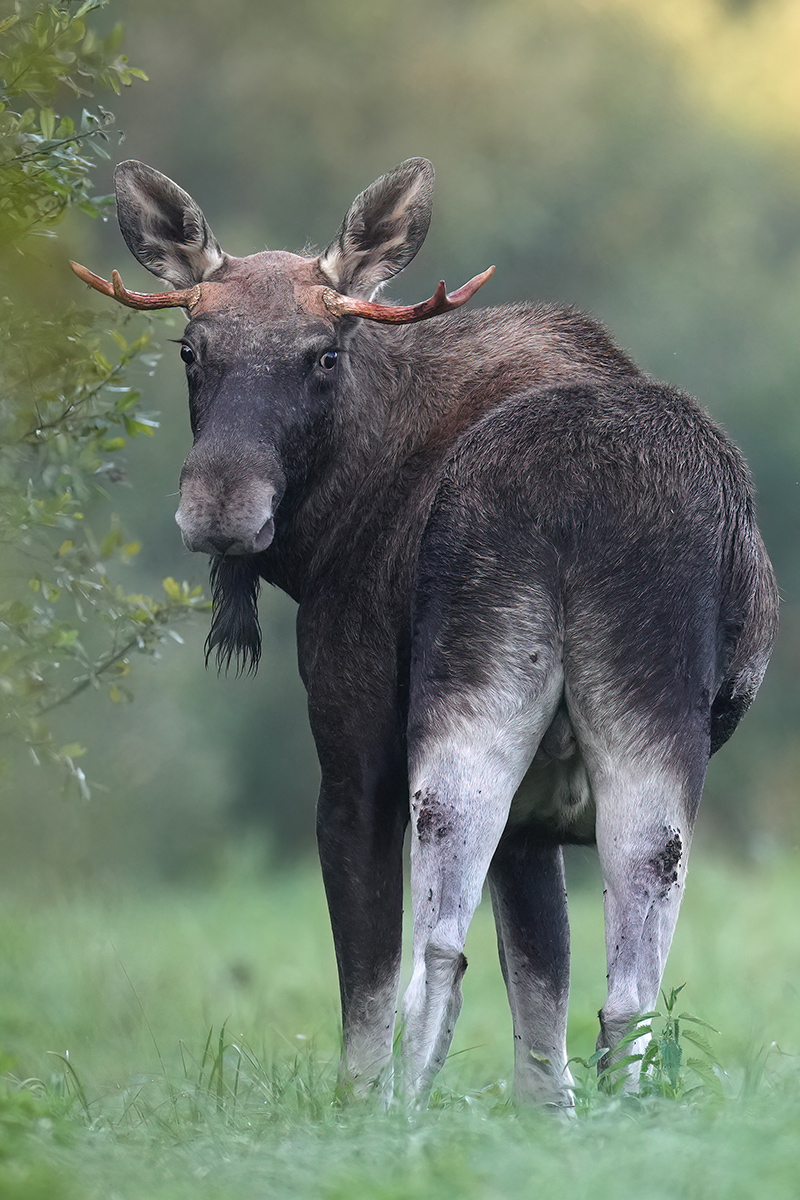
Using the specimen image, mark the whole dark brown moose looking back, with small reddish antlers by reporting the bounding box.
[72,158,777,1110]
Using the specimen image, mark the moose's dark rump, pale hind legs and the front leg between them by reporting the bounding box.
[405,380,774,1103]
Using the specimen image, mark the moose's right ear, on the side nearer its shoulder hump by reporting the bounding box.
[319,158,433,298]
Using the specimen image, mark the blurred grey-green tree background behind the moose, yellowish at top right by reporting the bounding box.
[0,0,800,878]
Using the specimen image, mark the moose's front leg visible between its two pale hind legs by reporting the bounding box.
[489,829,572,1108]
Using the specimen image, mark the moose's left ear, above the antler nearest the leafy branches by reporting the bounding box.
[114,158,225,288]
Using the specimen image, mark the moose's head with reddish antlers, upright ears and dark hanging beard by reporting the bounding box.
[71,158,494,667]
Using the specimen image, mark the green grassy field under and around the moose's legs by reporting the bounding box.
[0,852,800,1200]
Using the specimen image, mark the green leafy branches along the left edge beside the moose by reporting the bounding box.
[0,0,204,794]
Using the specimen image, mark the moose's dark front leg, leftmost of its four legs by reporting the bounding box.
[317,784,408,1102]
